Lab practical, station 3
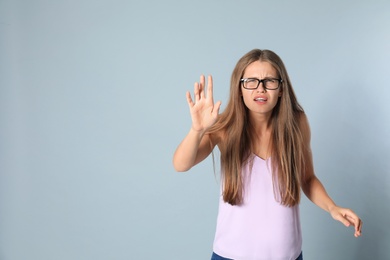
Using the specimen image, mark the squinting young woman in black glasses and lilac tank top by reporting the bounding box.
[173,49,362,260]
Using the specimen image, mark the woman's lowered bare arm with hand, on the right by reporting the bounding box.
[300,115,363,237]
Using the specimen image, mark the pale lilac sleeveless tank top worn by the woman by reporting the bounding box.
[213,156,302,260]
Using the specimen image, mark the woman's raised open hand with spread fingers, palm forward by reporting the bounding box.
[186,75,221,133]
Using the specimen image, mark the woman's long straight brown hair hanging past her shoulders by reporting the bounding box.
[209,49,304,206]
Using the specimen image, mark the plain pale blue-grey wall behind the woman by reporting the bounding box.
[0,0,390,260]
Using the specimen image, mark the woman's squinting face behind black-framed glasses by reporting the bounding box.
[241,61,282,116]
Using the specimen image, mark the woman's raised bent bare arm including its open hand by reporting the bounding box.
[173,75,221,171]
